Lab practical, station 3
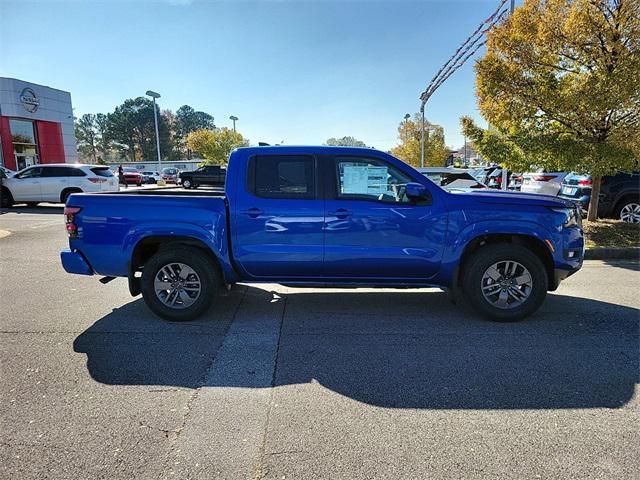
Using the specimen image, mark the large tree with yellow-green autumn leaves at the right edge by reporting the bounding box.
[472,0,640,220]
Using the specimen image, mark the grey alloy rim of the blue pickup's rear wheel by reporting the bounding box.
[153,262,202,310]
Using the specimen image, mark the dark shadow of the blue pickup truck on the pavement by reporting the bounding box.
[74,287,639,409]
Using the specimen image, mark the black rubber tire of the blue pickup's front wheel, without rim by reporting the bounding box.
[463,243,548,322]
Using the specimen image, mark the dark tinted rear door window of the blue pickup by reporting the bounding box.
[249,155,316,199]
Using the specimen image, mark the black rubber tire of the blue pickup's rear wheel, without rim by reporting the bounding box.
[140,246,221,322]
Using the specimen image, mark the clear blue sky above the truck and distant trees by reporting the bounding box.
[0,0,499,149]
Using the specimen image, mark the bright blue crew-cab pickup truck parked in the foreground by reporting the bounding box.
[61,146,584,321]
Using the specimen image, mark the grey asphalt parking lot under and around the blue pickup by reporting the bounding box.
[0,206,640,480]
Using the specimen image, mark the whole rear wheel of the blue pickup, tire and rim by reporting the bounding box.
[141,246,220,322]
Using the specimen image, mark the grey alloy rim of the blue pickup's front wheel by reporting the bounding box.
[480,260,533,310]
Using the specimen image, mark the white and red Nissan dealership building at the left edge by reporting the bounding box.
[0,77,78,170]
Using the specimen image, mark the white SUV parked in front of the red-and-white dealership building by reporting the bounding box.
[2,163,119,207]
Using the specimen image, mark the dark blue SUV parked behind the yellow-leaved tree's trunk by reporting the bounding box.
[558,172,640,223]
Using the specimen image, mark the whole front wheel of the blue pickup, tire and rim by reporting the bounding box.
[463,244,548,322]
